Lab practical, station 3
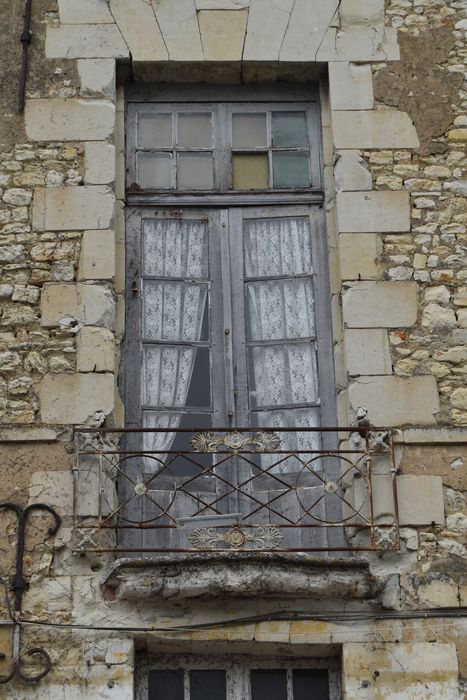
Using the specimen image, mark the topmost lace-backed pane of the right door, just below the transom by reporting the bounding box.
[243,217,312,277]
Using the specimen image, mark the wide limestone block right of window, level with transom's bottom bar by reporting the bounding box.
[337,190,410,233]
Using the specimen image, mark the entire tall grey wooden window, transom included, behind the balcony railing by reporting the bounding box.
[125,89,335,544]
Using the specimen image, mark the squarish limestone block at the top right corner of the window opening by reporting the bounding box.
[328,62,374,110]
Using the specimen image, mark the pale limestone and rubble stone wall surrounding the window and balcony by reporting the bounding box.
[0,0,467,700]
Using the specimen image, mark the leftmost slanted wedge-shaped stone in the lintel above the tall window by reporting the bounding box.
[110,0,169,62]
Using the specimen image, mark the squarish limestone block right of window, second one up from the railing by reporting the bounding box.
[344,328,392,375]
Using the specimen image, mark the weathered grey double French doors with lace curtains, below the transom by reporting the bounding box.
[121,205,335,548]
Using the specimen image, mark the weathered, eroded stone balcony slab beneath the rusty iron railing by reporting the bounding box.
[102,552,375,602]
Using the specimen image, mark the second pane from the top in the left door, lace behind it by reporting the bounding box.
[143,281,208,342]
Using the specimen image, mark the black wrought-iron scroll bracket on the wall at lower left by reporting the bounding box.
[0,503,61,683]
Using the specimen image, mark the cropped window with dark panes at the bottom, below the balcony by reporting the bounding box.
[137,656,340,700]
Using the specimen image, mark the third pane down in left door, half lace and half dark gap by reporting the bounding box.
[143,345,211,408]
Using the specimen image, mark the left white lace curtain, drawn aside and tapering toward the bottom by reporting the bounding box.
[143,220,208,470]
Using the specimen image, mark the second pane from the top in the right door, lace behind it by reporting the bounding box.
[246,279,315,340]
